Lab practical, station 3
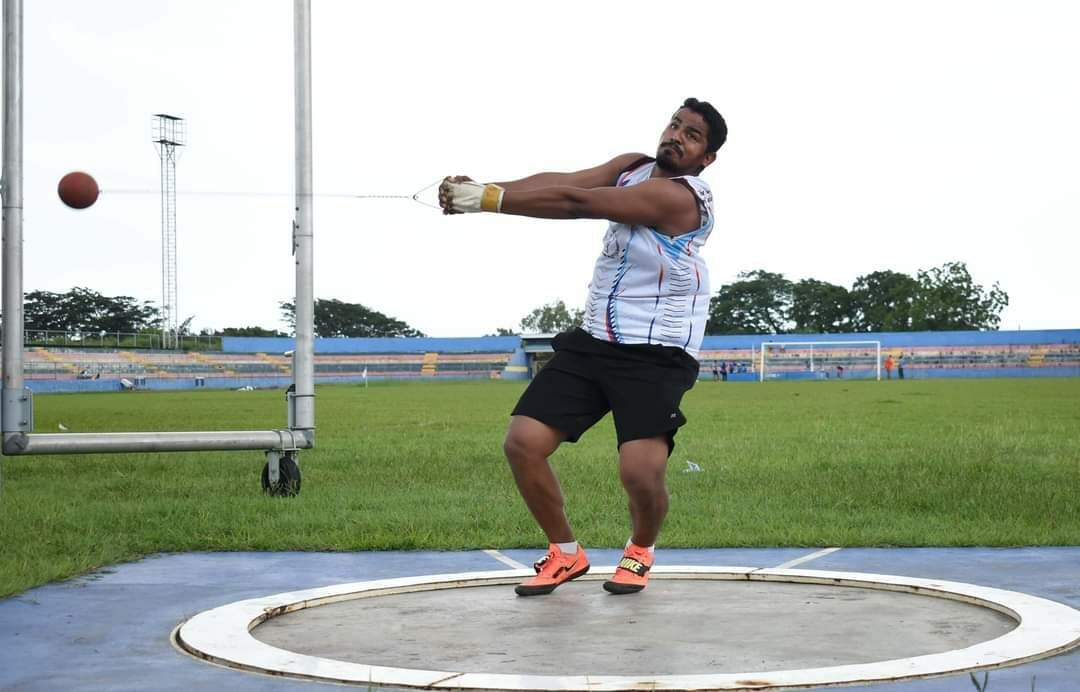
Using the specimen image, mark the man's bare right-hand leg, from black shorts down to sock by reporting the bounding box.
[619,436,667,547]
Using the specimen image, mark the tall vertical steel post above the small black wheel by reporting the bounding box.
[289,0,315,430]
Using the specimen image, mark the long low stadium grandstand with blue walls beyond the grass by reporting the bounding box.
[8,329,1080,392]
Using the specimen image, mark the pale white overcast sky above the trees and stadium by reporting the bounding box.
[4,0,1080,337]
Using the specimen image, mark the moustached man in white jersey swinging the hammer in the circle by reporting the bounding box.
[440,98,727,596]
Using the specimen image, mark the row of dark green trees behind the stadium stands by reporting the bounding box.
[6,262,1009,338]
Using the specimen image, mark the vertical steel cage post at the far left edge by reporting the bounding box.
[0,0,31,437]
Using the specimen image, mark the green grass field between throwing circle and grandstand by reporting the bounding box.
[0,379,1080,596]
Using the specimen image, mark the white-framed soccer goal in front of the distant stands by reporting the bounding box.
[758,340,881,382]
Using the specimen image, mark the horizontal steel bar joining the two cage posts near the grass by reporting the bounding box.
[3,430,315,456]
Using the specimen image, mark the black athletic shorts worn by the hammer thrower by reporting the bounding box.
[513,329,698,454]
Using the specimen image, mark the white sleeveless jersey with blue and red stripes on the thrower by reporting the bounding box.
[584,162,713,357]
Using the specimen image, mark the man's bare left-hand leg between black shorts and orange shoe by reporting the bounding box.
[502,416,574,543]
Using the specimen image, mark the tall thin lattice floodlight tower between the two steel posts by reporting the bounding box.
[152,113,184,349]
